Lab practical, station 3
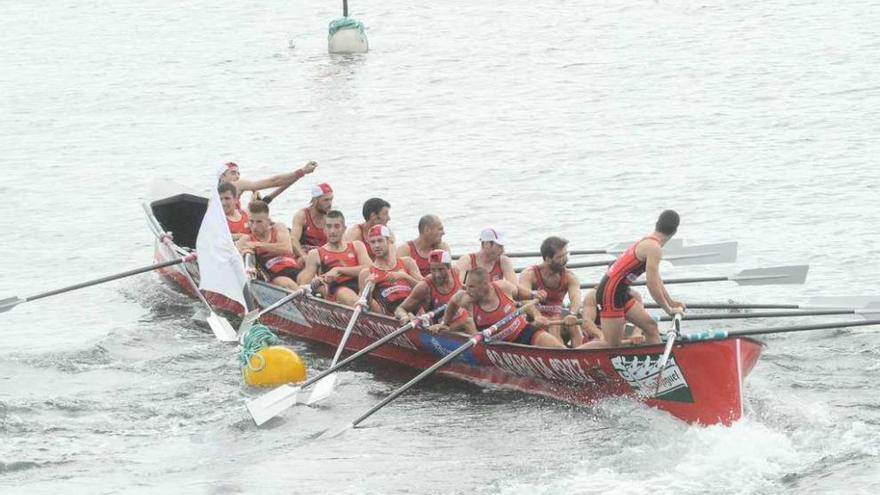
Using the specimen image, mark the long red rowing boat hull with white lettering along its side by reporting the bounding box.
[150,194,763,425]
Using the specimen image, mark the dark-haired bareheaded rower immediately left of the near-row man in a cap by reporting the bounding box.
[297,210,370,306]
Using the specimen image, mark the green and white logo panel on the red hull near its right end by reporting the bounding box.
[611,354,694,402]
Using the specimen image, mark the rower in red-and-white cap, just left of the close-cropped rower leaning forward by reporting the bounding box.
[394,249,476,334]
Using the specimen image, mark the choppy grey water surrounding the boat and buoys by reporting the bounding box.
[0,0,880,493]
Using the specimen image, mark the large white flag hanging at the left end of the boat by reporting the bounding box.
[196,187,248,311]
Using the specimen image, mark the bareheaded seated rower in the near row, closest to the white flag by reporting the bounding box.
[235,199,301,289]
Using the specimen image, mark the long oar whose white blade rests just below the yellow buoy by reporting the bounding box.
[245,304,446,426]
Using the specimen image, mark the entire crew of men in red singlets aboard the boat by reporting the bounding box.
[218,162,685,348]
